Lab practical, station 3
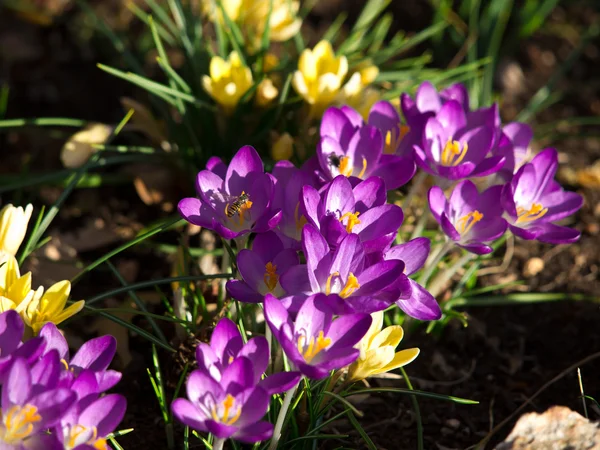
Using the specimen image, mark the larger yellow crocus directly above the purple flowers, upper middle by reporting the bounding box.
[292,41,348,117]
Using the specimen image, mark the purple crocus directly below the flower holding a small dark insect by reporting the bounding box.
[301,175,404,253]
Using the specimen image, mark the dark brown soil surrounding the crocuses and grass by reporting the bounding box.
[0,1,600,450]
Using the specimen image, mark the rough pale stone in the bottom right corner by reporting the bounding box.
[496,406,600,450]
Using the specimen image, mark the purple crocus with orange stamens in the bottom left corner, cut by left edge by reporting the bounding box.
[0,358,76,450]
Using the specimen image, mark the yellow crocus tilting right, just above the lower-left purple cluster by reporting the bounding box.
[22,280,85,335]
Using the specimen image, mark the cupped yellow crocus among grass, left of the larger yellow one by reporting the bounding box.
[202,52,253,114]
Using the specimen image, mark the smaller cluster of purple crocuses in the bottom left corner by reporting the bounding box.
[0,310,126,450]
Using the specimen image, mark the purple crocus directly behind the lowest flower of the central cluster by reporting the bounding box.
[196,318,300,395]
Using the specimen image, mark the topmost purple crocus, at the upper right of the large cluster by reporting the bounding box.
[414,100,505,180]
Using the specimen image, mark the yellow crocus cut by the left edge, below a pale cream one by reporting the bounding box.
[0,254,34,313]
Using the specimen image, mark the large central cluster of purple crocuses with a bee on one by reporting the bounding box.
[173,83,582,442]
